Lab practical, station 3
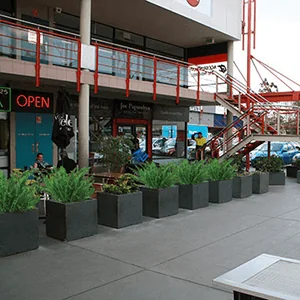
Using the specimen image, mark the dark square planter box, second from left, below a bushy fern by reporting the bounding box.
[46,199,97,241]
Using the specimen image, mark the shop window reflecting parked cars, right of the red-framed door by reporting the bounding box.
[152,120,186,159]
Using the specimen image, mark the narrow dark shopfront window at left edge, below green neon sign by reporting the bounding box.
[0,112,9,176]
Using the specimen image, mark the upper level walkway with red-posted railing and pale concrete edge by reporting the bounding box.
[0,15,220,106]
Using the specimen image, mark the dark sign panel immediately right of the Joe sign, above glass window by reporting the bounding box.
[153,105,189,122]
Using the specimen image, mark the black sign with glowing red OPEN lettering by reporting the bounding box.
[12,91,53,113]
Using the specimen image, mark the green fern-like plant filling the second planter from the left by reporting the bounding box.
[44,168,94,203]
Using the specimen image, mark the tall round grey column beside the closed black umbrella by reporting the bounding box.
[78,0,91,168]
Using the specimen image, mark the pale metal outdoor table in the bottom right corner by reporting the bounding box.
[213,254,300,300]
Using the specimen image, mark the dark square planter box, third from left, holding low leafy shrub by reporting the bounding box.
[98,192,143,228]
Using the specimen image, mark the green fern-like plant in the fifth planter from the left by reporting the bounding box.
[176,160,207,185]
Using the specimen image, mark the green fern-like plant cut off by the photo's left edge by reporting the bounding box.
[0,171,40,213]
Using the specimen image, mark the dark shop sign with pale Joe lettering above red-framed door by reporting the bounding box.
[115,101,152,120]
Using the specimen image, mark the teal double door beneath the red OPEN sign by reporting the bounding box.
[16,113,53,169]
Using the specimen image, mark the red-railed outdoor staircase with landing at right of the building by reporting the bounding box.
[202,71,299,159]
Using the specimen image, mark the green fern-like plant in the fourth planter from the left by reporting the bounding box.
[136,162,177,189]
